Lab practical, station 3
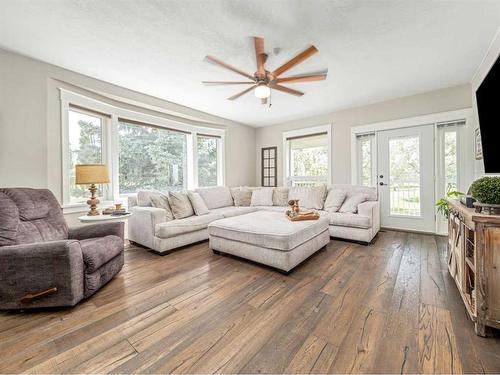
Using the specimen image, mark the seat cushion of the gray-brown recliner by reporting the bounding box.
[80,236,123,273]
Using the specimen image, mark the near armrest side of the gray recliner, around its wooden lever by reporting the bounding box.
[0,240,84,309]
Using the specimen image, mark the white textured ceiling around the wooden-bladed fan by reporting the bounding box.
[0,0,500,126]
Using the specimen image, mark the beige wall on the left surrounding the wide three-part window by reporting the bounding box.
[0,49,256,223]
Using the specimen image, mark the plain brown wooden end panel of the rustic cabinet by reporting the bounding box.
[484,227,500,322]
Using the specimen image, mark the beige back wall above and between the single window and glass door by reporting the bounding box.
[255,84,471,185]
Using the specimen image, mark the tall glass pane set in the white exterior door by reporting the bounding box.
[389,136,421,216]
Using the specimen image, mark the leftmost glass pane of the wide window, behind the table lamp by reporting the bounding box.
[68,110,102,203]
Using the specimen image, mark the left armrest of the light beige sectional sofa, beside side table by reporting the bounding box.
[128,206,167,249]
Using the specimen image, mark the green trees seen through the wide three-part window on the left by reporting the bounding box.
[70,116,217,201]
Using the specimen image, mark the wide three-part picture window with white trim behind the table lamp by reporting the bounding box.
[61,89,225,210]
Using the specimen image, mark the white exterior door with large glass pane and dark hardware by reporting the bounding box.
[377,125,436,232]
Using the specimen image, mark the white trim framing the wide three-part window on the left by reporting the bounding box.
[59,88,226,213]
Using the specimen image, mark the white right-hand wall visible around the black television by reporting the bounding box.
[470,28,500,178]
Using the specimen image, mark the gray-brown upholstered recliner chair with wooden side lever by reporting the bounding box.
[0,188,124,310]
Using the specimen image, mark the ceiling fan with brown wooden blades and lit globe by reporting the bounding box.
[202,37,327,104]
